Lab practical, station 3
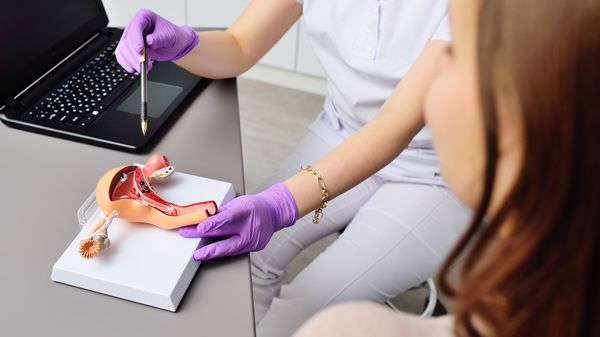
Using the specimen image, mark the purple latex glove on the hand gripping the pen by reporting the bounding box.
[115,9,199,73]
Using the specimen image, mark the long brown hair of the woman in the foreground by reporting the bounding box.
[440,0,600,337]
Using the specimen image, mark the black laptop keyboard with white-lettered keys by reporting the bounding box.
[27,40,139,129]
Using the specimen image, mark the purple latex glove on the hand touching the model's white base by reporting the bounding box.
[179,183,298,261]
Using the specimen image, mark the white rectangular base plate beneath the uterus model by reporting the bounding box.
[51,172,235,311]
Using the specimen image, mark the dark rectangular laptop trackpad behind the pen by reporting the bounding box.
[117,81,183,118]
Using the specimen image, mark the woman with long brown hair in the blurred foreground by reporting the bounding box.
[297,0,600,337]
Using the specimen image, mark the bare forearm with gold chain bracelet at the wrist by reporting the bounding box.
[284,41,445,217]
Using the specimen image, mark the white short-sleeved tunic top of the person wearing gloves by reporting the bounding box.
[296,0,450,185]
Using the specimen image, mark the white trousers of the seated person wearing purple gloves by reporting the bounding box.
[250,132,471,337]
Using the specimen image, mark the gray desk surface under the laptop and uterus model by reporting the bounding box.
[0,79,254,337]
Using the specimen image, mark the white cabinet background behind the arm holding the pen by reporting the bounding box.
[102,0,325,95]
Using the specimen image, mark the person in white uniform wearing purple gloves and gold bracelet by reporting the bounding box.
[117,0,471,336]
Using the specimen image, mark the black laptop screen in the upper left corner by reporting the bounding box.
[0,0,108,106]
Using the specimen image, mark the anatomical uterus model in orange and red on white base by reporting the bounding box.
[79,154,217,259]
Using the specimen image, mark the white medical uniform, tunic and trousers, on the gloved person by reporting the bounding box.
[250,0,471,337]
